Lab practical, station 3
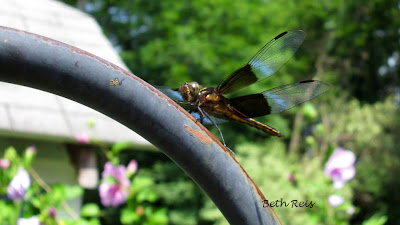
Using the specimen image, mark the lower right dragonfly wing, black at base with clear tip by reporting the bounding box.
[229,80,331,118]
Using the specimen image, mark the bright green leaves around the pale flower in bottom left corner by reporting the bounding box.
[0,147,99,225]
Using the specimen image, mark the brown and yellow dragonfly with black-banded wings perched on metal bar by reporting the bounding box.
[158,30,331,146]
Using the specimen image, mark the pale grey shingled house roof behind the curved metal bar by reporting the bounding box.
[0,0,150,145]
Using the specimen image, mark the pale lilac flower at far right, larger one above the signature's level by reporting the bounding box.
[324,148,356,189]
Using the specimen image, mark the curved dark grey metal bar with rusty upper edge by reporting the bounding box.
[0,27,280,225]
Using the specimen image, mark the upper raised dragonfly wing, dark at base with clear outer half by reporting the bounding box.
[217,30,306,94]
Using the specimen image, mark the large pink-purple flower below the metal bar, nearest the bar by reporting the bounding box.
[99,162,131,207]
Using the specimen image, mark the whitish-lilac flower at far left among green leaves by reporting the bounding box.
[7,167,31,200]
